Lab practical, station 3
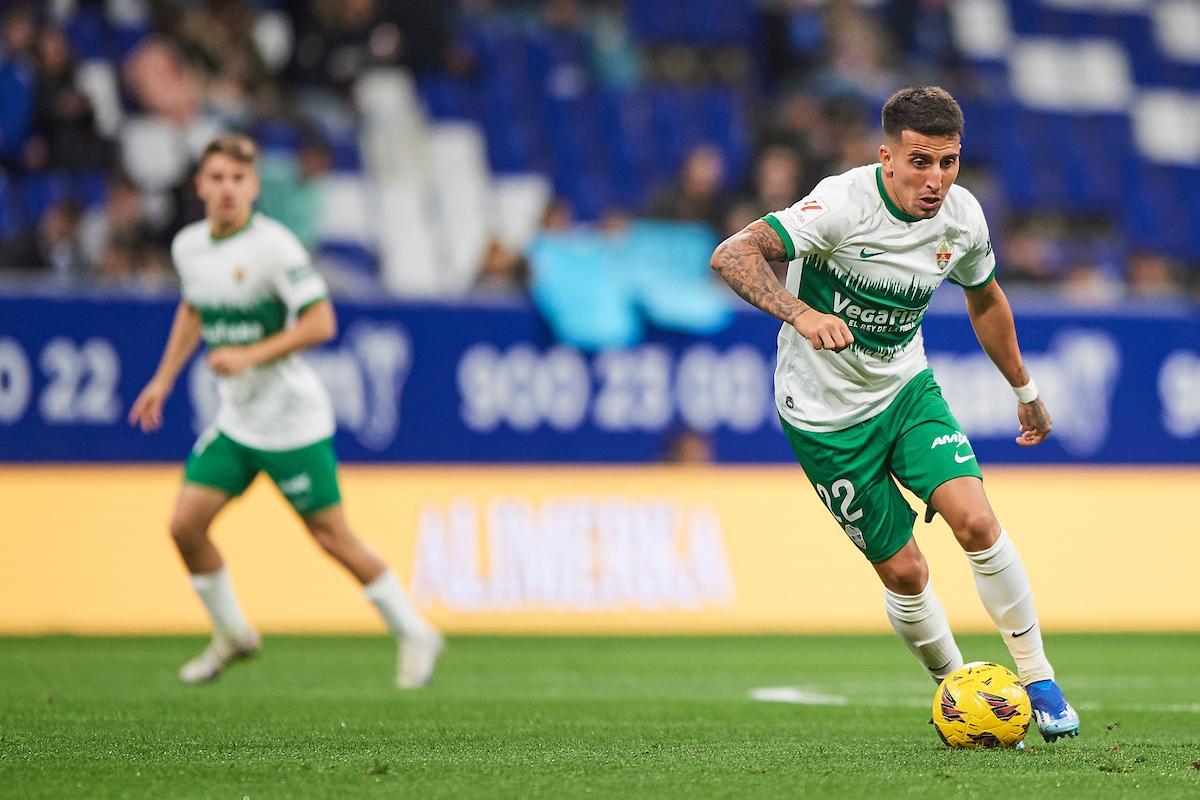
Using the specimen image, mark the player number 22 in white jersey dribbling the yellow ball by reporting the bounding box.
[712,86,1079,741]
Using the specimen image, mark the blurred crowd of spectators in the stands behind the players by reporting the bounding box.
[0,0,1200,305]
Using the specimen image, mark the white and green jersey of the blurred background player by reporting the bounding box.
[170,213,334,450]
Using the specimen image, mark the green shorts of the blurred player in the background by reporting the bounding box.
[184,429,342,517]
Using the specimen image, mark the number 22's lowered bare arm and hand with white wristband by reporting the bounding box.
[965,281,1054,447]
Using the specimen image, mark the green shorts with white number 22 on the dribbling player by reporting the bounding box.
[784,369,983,564]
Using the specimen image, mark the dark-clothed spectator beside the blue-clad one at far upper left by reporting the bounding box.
[25,26,114,172]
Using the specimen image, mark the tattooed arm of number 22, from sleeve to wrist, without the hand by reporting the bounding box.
[713,222,809,321]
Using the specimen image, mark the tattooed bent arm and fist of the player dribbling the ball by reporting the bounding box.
[710,219,854,350]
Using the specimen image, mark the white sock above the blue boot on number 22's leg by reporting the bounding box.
[967,529,1054,684]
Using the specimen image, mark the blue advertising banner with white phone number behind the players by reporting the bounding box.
[0,296,1200,463]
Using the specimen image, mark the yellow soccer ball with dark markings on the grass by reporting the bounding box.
[934,661,1033,747]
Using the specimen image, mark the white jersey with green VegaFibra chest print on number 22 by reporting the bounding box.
[764,164,996,432]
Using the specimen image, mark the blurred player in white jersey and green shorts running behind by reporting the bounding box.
[130,134,442,688]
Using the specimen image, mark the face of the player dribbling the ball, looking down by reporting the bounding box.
[880,131,962,219]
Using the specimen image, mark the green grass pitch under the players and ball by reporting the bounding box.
[0,634,1200,800]
